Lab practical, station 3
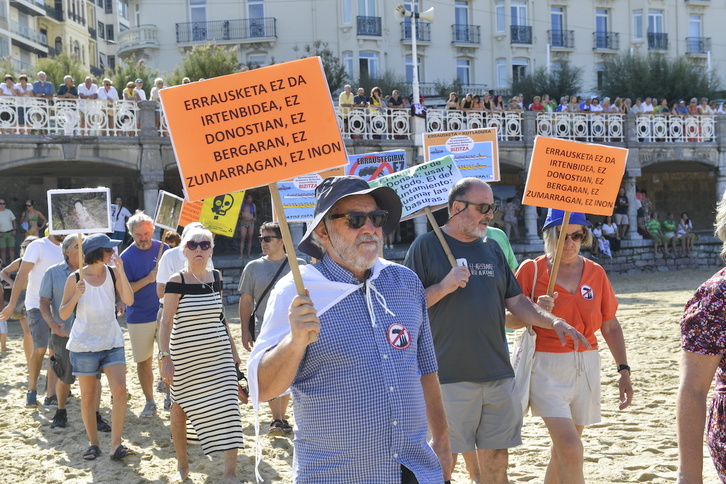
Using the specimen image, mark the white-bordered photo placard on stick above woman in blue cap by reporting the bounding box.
[48,187,113,279]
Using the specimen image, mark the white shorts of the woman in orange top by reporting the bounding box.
[529,350,601,425]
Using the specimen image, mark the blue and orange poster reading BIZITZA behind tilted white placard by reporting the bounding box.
[423,128,500,182]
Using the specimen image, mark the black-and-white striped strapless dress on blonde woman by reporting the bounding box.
[166,271,243,454]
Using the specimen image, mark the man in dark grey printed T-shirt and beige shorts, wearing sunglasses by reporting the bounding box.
[404,178,588,483]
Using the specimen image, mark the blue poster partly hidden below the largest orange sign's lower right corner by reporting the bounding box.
[277,167,345,222]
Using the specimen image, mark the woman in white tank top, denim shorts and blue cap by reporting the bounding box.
[59,234,135,460]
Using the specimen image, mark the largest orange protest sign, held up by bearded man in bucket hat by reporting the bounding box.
[160,57,348,201]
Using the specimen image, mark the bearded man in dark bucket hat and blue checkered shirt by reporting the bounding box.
[249,176,451,484]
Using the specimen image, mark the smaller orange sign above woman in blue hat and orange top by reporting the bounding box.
[522,136,628,215]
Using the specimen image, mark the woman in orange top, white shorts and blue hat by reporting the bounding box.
[507,209,633,484]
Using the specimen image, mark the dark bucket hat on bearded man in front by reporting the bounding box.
[297,175,402,259]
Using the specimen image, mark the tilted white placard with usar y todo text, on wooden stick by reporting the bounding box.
[368,156,462,267]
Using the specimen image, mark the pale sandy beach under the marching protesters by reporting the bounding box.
[0,268,719,484]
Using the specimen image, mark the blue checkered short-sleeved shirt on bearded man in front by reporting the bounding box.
[291,256,443,484]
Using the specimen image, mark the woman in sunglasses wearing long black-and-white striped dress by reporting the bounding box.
[159,227,243,483]
